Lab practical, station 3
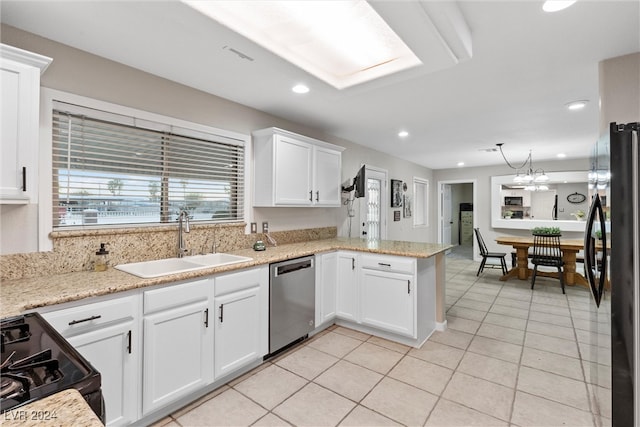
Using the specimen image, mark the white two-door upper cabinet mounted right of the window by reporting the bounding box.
[253,128,344,207]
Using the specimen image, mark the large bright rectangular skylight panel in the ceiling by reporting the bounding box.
[183,0,422,89]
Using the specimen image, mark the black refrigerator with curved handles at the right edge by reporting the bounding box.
[584,123,640,427]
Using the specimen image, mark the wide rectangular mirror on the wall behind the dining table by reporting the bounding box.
[491,171,591,231]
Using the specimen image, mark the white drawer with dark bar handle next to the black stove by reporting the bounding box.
[42,295,138,337]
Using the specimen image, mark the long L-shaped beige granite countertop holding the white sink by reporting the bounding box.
[0,237,452,318]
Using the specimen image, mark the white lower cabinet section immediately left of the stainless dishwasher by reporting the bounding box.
[214,267,269,380]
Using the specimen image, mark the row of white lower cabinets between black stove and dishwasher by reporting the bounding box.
[41,266,269,426]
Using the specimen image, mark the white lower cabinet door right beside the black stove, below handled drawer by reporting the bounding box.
[68,321,141,426]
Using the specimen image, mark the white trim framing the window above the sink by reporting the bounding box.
[38,87,253,252]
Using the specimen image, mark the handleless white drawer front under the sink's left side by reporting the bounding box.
[143,279,213,314]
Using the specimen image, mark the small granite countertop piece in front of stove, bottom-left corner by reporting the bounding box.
[0,389,103,427]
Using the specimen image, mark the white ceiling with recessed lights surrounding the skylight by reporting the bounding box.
[0,0,640,169]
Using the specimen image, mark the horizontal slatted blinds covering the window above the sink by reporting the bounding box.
[52,105,244,229]
